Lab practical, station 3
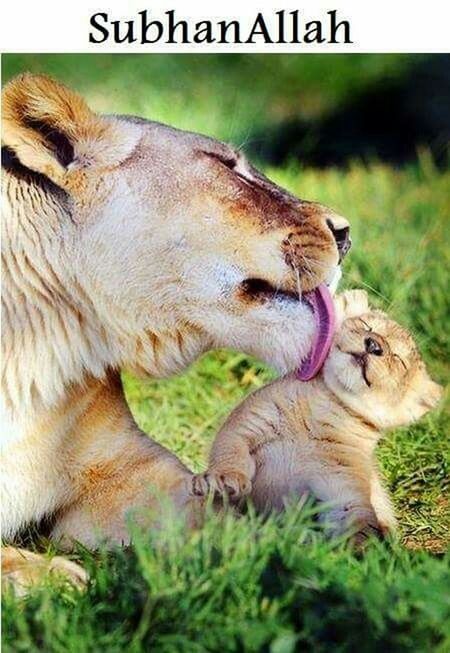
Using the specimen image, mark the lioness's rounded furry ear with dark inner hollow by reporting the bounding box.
[2,73,138,186]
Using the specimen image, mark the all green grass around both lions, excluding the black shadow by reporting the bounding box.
[3,55,450,653]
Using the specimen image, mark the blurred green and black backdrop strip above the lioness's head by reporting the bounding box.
[3,54,450,166]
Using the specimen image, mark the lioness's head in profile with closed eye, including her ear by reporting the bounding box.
[3,75,349,374]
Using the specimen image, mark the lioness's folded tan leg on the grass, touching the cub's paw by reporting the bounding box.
[51,429,203,548]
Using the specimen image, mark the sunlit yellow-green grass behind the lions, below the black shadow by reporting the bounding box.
[125,154,450,551]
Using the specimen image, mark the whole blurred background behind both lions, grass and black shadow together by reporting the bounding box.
[2,54,450,551]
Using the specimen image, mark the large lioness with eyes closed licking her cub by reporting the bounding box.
[2,74,350,583]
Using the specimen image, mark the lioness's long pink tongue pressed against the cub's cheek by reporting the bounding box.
[297,283,335,381]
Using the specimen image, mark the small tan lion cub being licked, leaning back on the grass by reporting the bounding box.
[194,290,442,542]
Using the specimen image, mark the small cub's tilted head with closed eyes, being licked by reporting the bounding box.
[323,290,442,428]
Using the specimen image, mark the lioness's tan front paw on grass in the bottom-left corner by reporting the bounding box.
[2,546,88,596]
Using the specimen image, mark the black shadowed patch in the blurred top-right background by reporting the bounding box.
[253,55,450,167]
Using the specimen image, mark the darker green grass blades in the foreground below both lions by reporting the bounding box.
[3,509,450,653]
